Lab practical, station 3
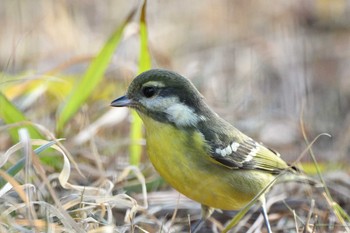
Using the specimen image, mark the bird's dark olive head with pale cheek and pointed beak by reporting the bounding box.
[111,69,208,127]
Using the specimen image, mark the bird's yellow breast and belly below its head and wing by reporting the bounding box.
[140,114,274,210]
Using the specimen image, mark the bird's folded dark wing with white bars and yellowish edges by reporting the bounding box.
[198,114,289,174]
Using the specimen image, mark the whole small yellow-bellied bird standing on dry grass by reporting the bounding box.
[111,69,296,232]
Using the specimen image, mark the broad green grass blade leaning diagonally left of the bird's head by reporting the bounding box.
[57,10,135,132]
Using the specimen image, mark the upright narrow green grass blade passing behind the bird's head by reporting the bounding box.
[129,0,152,166]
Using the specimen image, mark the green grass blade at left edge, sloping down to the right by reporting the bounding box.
[0,92,44,142]
